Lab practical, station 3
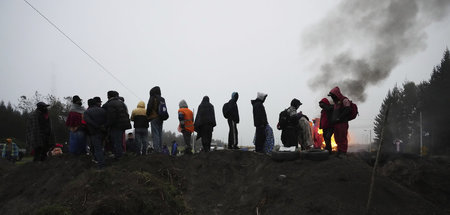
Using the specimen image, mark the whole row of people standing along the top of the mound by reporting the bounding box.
[27,86,356,167]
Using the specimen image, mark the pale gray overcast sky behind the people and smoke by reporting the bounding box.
[0,0,450,145]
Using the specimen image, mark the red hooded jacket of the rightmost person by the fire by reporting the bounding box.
[329,87,351,123]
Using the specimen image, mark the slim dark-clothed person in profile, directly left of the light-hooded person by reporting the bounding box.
[222,92,239,149]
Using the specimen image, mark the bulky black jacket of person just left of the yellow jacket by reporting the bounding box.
[103,97,131,130]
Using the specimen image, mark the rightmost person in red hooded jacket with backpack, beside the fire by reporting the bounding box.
[328,87,351,157]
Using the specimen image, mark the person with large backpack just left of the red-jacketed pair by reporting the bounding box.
[277,98,302,148]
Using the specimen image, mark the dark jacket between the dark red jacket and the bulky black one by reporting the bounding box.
[83,106,106,135]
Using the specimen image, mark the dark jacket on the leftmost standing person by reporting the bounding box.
[26,109,54,148]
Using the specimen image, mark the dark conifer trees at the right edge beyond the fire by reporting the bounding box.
[374,48,450,155]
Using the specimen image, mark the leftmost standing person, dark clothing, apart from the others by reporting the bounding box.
[26,102,54,161]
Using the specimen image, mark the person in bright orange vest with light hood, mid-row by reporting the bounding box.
[178,100,194,154]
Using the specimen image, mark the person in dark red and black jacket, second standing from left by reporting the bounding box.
[66,95,87,155]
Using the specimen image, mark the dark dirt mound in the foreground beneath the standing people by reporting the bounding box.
[0,151,445,215]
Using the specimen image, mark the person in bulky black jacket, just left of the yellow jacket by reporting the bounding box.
[103,90,131,159]
